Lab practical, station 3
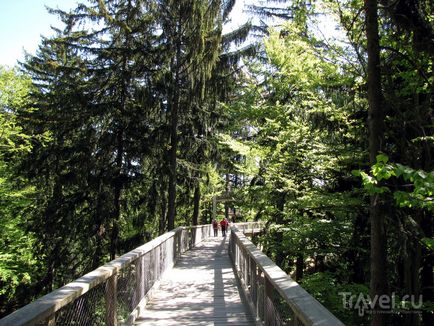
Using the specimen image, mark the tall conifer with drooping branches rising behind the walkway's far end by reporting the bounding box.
[155,0,244,230]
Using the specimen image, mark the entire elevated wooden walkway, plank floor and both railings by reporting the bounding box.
[0,222,343,326]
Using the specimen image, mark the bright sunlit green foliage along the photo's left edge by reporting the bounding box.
[0,67,37,314]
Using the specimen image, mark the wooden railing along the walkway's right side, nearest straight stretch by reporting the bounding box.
[229,224,344,326]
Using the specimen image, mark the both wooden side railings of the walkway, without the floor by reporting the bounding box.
[0,222,343,326]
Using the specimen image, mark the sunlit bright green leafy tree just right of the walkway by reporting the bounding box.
[221,12,366,284]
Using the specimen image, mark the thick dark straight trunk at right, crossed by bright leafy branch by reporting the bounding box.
[365,0,388,326]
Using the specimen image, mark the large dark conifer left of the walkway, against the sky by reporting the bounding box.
[20,1,159,285]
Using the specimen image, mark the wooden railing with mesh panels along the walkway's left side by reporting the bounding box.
[0,225,212,326]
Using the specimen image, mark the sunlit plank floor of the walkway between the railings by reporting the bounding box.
[134,236,255,326]
